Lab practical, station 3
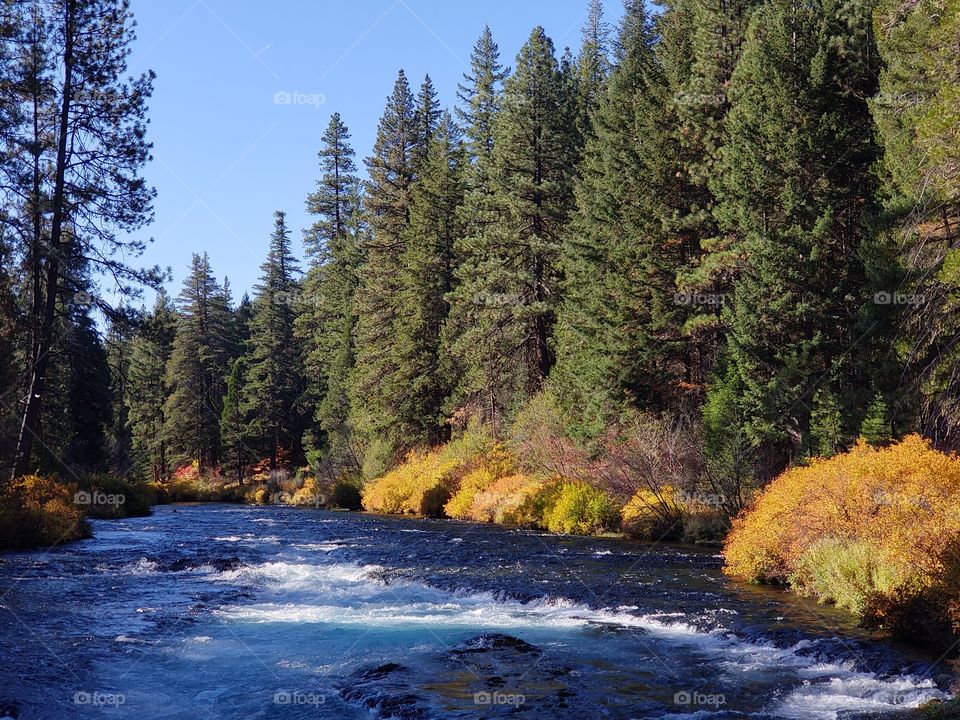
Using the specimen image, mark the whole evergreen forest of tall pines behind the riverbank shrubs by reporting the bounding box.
[0,0,960,536]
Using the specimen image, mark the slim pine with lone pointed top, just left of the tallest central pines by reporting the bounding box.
[294,113,361,470]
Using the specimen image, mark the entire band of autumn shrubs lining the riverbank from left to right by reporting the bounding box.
[7,428,960,660]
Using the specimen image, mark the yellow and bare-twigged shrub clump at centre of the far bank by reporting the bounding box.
[363,398,729,542]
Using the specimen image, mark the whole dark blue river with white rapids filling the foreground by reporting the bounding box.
[0,505,945,720]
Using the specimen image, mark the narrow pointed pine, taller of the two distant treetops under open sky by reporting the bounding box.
[243,210,302,471]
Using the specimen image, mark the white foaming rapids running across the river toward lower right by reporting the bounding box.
[218,556,948,720]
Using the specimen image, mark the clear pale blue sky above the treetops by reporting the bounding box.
[130,0,621,303]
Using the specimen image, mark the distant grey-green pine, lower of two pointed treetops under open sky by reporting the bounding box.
[163,254,229,472]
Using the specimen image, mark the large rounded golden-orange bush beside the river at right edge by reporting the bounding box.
[724,435,960,644]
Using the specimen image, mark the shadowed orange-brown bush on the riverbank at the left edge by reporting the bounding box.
[0,475,90,550]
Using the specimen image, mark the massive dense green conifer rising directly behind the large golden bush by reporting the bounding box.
[722,0,877,473]
